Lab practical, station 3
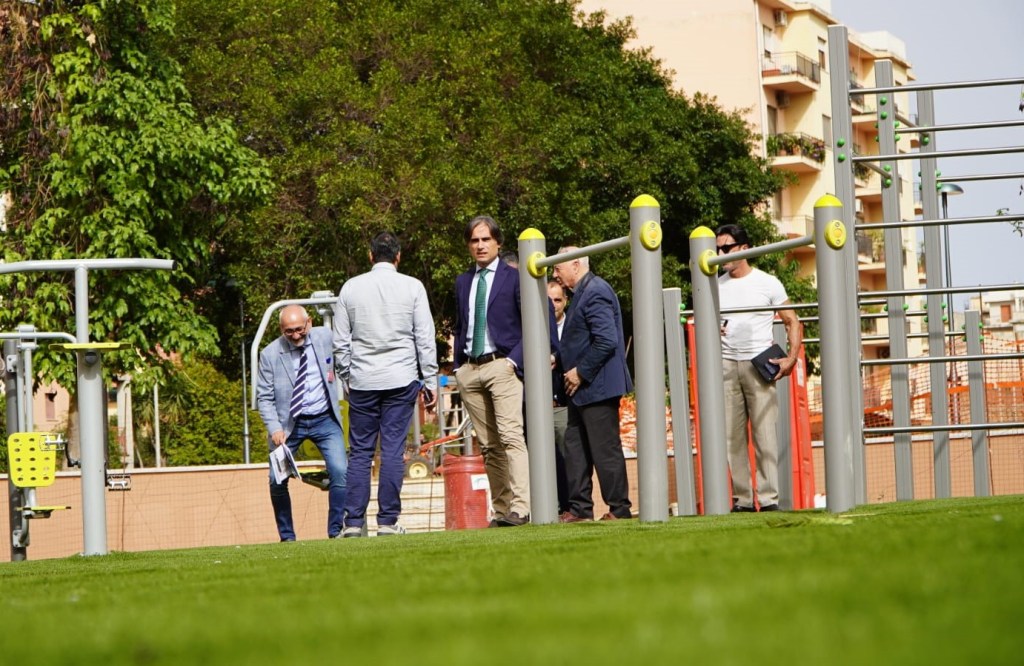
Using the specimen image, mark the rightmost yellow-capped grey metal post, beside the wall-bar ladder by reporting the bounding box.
[814,195,859,512]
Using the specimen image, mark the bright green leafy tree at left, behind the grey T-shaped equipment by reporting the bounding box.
[0,0,270,390]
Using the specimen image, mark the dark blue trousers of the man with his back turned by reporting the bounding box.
[345,381,421,527]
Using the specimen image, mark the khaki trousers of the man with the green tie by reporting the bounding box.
[455,359,529,518]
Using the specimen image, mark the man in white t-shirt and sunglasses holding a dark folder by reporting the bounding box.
[715,224,803,512]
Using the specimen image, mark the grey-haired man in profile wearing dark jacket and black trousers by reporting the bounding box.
[554,247,633,523]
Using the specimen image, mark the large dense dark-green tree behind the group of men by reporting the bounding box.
[168,0,798,358]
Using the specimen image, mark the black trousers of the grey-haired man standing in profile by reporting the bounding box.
[565,398,632,518]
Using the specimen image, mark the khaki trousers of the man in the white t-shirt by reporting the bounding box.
[722,360,778,506]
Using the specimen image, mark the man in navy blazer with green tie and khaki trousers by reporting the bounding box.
[455,215,529,527]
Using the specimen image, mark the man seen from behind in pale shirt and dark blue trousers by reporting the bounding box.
[334,232,437,537]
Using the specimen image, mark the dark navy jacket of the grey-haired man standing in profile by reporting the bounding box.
[558,273,633,407]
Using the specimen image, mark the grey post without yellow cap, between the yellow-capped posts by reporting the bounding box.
[662,288,697,515]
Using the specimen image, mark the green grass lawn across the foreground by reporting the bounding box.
[0,497,1024,666]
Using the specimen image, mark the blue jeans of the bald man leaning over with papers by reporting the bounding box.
[270,411,348,540]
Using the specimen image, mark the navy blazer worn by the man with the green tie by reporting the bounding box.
[453,261,558,377]
